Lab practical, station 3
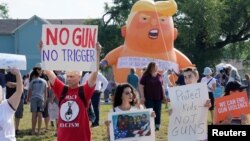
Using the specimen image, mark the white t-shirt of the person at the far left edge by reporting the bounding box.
[0,100,16,141]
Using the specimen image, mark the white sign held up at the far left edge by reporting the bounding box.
[0,53,27,70]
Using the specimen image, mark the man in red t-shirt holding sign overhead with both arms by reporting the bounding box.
[45,43,101,141]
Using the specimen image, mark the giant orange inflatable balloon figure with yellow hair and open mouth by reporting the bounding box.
[101,0,193,83]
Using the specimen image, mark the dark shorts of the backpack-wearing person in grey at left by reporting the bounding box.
[30,97,44,113]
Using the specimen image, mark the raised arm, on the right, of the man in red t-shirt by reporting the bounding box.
[88,43,101,87]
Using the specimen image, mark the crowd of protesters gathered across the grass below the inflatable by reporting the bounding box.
[0,44,250,141]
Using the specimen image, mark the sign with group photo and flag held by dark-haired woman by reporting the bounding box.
[109,109,155,141]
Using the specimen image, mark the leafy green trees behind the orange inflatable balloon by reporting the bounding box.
[102,0,250,70]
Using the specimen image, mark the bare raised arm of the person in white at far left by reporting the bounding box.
[8,68,23,110]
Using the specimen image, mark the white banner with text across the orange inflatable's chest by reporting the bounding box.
[117,56,179,72]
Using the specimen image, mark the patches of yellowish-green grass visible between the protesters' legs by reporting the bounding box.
[17,104,168,141]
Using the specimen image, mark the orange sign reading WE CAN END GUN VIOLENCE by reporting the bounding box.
[215,92,250,122]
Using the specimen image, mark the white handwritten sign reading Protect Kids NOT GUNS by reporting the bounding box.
[168,83,209,141]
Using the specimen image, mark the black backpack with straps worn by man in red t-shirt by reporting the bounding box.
[59,85,96,122]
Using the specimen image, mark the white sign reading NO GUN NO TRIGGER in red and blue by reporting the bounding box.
[41,24,98,71]
